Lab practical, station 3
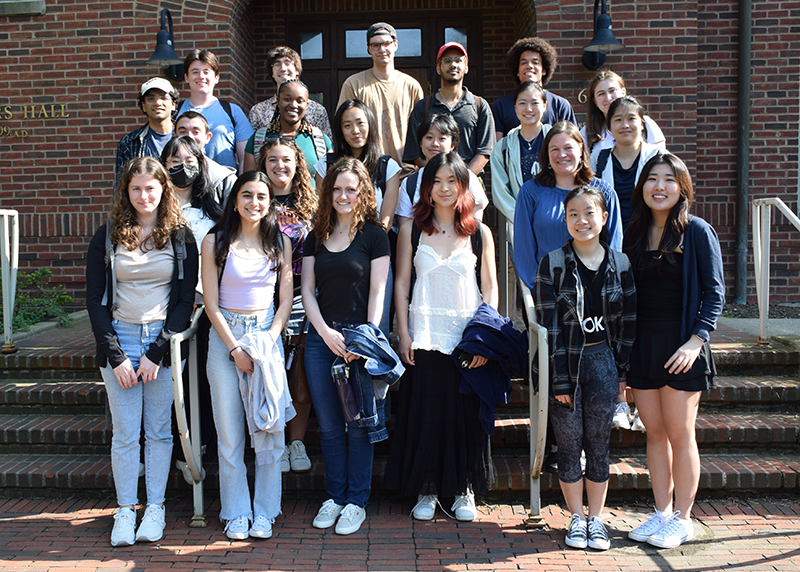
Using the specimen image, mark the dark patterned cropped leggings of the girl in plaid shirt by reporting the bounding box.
[550,344,619,483]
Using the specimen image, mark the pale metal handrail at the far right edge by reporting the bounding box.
[752,198,800,346]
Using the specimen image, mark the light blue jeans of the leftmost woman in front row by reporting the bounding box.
[100,320,172,506]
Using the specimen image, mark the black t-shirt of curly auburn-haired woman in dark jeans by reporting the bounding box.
[303,222,389,325]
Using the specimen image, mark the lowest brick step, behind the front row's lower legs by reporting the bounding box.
[0,454,800,494]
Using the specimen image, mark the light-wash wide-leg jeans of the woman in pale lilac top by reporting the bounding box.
[207,308,282,522]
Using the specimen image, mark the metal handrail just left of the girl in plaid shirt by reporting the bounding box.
[498,217,550,526]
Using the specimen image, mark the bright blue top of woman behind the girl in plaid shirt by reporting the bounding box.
[514,177,622,288]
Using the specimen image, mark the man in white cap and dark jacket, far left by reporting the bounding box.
[114,77,178,188]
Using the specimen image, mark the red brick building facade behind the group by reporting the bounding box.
[0,0,800,308]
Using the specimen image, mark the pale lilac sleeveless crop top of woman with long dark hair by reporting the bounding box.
[219,248,278,312]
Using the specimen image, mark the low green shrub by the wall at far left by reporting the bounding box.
[0,268,73,332]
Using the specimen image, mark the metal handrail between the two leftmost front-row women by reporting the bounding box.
[169,306,208,528]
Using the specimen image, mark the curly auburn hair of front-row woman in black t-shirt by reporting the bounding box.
[312,157,383,248]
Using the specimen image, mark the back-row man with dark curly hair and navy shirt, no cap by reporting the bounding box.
[492,38,577,141]
